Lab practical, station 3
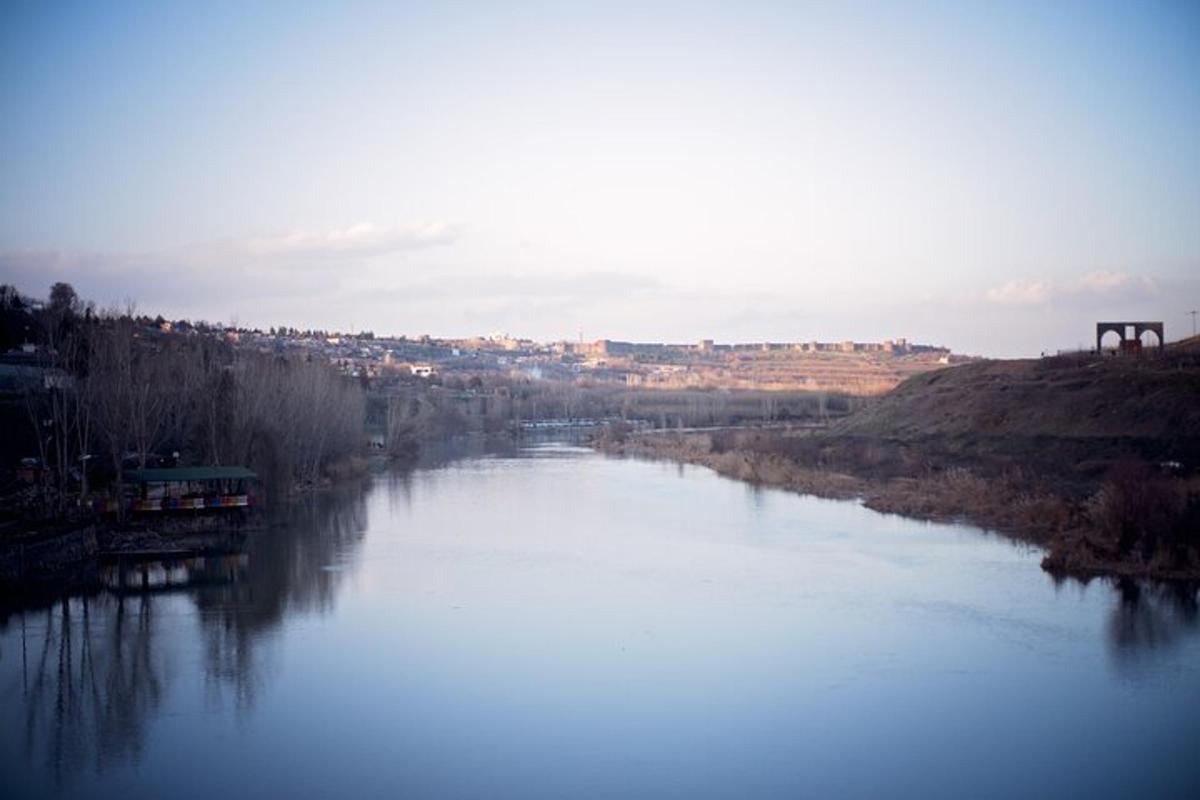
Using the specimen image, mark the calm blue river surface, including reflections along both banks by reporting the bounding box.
[0,445,1200,799]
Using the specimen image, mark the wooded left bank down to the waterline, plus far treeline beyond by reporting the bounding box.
[0,283,858,599]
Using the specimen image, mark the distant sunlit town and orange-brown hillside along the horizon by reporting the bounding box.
[148,319,955,397]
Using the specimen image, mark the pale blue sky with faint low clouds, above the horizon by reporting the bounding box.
[0,0,1200,356]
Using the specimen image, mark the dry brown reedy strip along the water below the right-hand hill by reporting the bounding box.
[592,431,1200,581]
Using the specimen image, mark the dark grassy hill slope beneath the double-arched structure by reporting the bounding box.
[836,348,1200,440]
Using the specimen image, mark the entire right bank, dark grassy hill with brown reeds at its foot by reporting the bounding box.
[593,351,1200,582]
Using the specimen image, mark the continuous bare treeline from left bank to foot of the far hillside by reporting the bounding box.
[0,283,862,522]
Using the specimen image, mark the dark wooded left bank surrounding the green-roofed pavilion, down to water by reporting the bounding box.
[0,283,366,599]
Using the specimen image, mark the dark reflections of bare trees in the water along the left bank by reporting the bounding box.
[0,487,366,787]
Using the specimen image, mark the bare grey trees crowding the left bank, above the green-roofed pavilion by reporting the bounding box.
[0,283,365,509]
